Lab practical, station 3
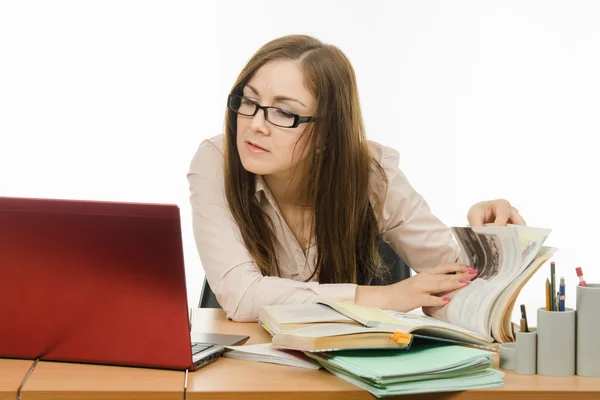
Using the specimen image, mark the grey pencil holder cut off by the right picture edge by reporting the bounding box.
[577,283,600,378]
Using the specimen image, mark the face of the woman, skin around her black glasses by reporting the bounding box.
[237,60,317,178]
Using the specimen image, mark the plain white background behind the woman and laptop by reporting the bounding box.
[0,0,600,324]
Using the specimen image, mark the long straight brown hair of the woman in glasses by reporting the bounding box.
[225,35,387,283]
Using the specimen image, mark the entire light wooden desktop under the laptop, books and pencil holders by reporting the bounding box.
[0,309,600,400]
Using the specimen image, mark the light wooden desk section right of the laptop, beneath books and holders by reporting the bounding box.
[187,309,600,400]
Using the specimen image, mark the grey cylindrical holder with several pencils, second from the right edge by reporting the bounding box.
[537,308,576,376]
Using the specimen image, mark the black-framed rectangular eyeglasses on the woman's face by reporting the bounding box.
[227,94,315,128]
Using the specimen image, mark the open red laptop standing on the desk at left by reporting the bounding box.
[0,197,248,370]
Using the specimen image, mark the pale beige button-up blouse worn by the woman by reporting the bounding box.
[187,135,461,321]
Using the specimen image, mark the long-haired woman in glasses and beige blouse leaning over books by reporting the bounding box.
[188,35,524,321]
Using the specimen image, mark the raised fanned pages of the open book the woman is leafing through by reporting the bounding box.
[431,225,557,343]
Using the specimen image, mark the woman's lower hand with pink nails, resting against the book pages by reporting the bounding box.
[355,263,477,312]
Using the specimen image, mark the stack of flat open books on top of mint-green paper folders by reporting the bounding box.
[259,299,504,397]
